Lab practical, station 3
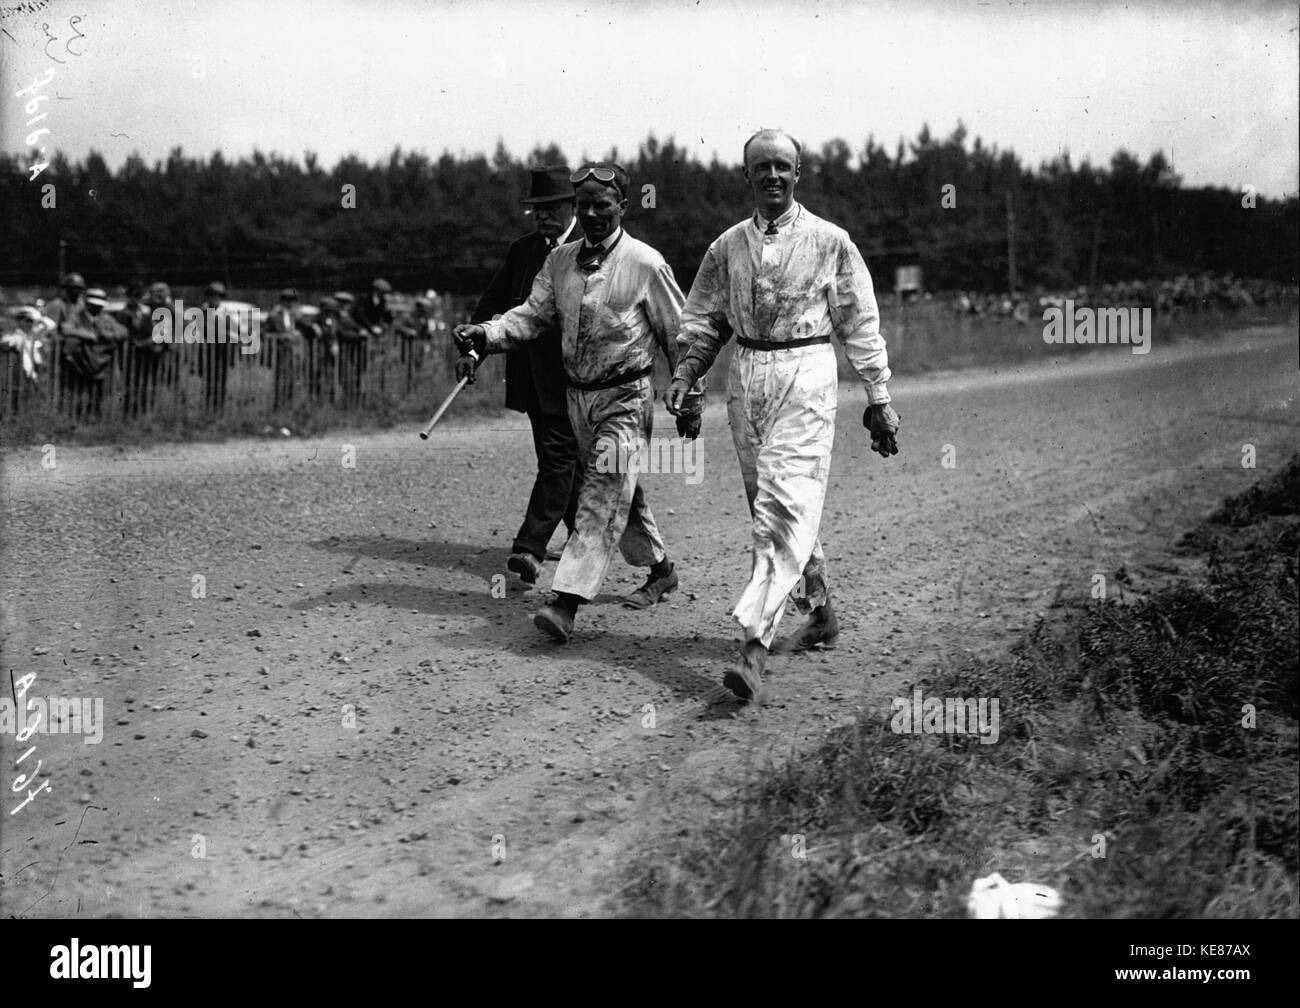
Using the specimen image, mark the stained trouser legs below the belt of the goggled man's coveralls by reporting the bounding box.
[551,377,668,601]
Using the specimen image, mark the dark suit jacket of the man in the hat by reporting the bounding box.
[469,222,582,415]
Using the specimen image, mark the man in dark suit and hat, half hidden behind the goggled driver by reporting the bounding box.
[471,165,582,584]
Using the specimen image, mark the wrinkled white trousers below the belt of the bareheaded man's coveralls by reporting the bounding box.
[727,343,839,646]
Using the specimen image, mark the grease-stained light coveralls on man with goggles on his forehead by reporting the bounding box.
[482,232,698,601]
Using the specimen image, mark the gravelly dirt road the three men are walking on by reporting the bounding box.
[0,329,1300,917]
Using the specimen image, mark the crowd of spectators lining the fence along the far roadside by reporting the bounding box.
[0,267,1300,418]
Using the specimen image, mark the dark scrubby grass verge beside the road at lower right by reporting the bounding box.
[621,455,1300,918]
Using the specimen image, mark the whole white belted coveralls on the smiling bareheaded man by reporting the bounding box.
[673,203,889,648]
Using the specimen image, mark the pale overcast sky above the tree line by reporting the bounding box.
[0,0,1300,196]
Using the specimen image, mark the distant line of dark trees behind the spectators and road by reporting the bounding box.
[0,122,1300,297]
